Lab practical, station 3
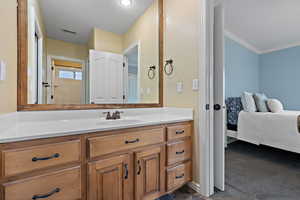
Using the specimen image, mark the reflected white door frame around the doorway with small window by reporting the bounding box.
[47,55,87,104]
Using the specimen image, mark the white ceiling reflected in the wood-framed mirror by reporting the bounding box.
[40,0,154,44]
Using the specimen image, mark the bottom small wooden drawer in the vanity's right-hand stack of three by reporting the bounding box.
[167,161,192,191]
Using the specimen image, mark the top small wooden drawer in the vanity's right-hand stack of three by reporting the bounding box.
[167,124,192,141]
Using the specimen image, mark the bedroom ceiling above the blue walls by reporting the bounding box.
[225,0,300,52]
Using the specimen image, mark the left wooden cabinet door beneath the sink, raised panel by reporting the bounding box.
[88,154,133,200]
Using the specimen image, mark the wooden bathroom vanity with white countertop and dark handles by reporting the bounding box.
[0,109,193,200]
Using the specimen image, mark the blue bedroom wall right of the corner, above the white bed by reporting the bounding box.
[260,46,300,110]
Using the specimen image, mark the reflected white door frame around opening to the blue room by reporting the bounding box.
[123,40,141,103]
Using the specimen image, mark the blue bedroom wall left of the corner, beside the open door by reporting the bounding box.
[225,37,259,97]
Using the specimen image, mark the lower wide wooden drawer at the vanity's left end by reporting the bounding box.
[3,167,81,200]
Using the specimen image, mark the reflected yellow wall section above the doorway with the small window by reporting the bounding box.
[47,38,88,60]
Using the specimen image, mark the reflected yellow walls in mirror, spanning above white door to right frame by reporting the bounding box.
[88,0,159,103]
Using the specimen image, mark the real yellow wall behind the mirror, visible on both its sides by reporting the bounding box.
[0,0,199,187]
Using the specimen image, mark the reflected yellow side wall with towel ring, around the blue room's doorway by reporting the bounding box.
[123,0,159,103]
